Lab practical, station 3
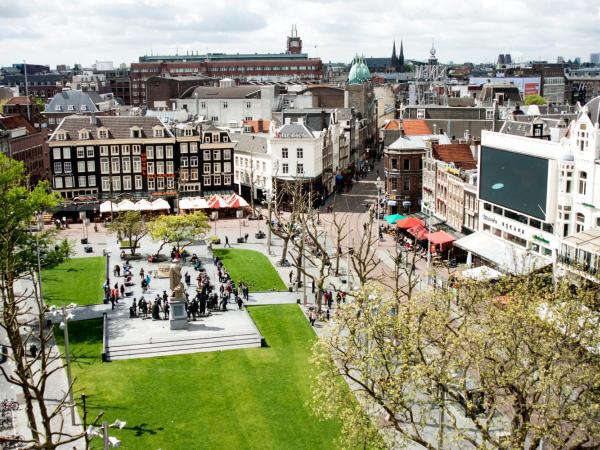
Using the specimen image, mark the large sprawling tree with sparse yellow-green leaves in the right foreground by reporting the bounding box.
[313,275,600,450]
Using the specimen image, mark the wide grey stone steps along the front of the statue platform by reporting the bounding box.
[107,333,262,361]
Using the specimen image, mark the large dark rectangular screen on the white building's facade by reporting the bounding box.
[479,146,548,220]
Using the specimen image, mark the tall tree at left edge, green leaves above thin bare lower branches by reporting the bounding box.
[0,154,83,449]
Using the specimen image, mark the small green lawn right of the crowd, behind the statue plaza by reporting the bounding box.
[213,248,286,291]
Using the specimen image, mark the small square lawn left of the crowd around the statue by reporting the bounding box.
[42,256,106,305]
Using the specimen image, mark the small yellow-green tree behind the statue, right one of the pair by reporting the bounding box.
[148,211,210,255]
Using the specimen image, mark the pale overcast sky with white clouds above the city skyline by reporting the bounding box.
[0,0,600,67]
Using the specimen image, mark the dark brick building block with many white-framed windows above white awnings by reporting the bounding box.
[49,116,234,199]
